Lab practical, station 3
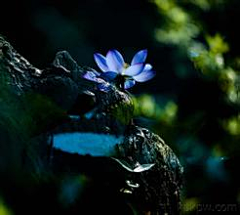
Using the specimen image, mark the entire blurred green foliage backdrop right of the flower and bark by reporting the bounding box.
[148,0,240,214]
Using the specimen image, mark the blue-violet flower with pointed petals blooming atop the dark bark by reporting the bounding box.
[84,49,155,89]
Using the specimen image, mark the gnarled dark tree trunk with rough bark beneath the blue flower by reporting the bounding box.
[0,38,183,215]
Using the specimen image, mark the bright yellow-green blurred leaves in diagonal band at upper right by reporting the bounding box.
[153,0,240,139]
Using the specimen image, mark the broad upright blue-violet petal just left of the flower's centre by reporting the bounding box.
[106,49,124,73]
